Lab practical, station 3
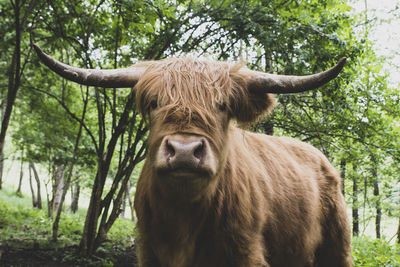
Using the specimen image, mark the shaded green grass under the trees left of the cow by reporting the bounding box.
[0,188,134,266]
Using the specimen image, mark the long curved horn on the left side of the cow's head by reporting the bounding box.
[33,44,145,88]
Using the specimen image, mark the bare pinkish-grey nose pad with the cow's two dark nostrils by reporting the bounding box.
[165,138,205,167]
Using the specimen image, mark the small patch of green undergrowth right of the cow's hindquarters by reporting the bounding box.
[353,237,400,267]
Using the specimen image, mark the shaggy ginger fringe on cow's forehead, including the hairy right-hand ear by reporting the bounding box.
[135,57,275,129]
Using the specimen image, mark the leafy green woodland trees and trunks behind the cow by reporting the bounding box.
[0,0,400,266]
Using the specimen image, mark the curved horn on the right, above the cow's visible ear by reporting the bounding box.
[247,58,346,94]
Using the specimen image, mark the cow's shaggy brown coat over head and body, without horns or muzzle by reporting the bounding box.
[135,58,352,267]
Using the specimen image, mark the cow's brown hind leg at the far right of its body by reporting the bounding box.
[315,195,353,267]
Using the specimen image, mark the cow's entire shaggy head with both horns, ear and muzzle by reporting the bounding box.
[35,46,345,198]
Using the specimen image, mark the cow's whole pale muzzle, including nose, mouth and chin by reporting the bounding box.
[156,134,216,178]
